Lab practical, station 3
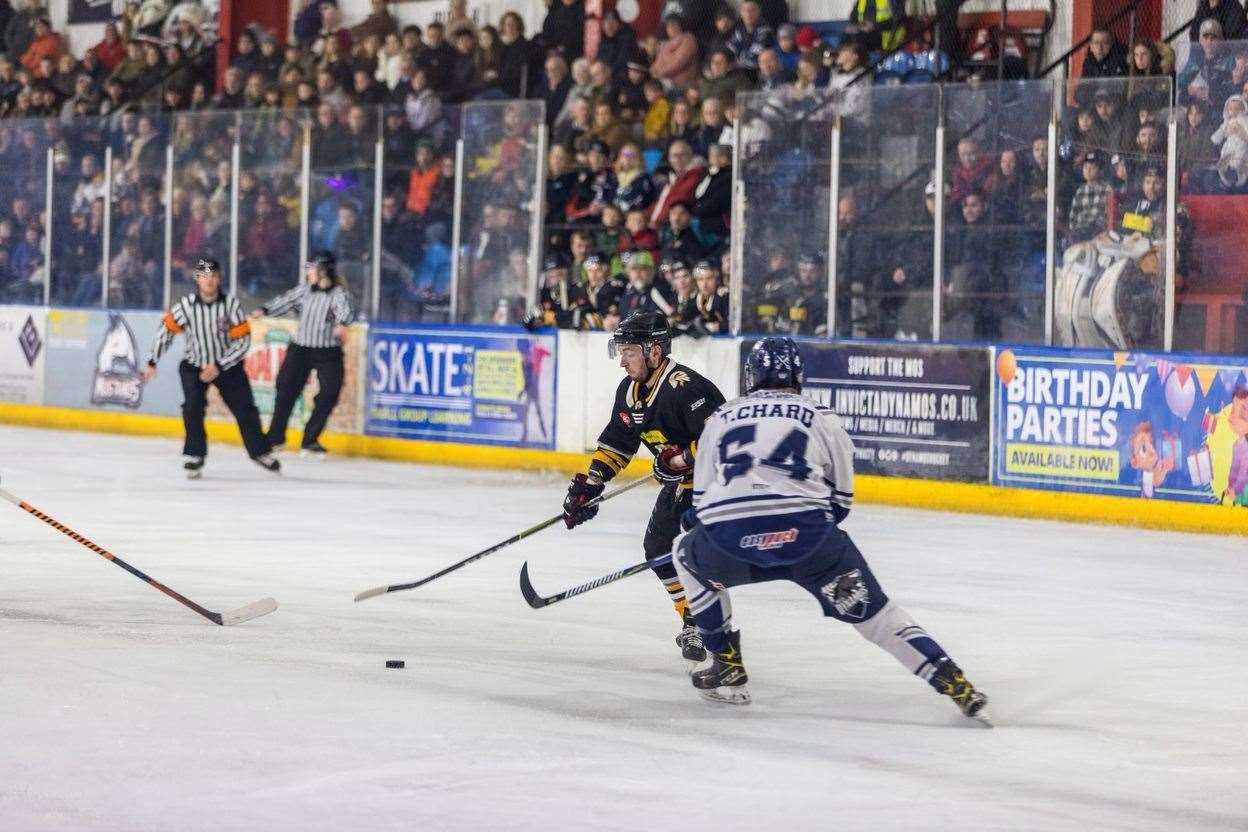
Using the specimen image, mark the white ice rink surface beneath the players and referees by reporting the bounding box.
[0,427,1248,832]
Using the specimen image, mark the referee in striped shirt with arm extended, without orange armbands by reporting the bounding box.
[251,251,354,458]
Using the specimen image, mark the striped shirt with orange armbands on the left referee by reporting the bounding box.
[147,292,251,370]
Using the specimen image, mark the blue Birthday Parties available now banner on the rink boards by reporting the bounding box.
[993,347,1248,506]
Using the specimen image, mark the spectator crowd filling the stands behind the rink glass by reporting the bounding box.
[0,0,1248,351]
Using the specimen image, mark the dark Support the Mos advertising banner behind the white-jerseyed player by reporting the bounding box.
[741,341,991,483]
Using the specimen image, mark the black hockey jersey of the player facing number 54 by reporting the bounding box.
[589,358,724,486]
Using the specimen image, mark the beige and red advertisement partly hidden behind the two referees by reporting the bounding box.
[207,318,364,434]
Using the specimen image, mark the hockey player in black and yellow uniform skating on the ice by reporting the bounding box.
[563,312,724,661]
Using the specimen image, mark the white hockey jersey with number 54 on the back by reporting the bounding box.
[694,390,854,566]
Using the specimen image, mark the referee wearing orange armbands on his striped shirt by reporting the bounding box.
[144,259,281,479]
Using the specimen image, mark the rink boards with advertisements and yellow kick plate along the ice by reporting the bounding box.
[0,306,1248,534]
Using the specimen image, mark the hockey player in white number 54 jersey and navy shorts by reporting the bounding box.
[673,337,990,723]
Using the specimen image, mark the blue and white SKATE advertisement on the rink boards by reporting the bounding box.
[364,327,555,449]
